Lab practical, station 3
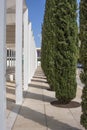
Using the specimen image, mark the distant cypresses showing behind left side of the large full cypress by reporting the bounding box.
[42,0,55,89]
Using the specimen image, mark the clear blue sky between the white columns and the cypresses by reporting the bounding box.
[26,0,80,47]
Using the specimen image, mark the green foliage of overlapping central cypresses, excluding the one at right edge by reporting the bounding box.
[41,0,78,103]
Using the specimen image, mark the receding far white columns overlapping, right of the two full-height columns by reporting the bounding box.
[24,10,37,91]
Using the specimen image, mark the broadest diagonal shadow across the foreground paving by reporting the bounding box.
[8,105,81,130]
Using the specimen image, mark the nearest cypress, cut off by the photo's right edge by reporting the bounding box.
[80,0,87,129]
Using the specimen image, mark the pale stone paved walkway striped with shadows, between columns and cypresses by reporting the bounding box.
[7,67,84,130]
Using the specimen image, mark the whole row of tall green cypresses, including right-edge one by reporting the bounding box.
[41,0,87,128]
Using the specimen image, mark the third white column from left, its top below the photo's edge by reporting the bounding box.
[24,9,29,91]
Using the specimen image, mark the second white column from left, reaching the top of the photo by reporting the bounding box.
[15,0,23,104]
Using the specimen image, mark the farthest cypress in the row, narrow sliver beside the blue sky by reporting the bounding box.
[41,1,49,76]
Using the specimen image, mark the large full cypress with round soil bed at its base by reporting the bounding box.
[55,0,78,103]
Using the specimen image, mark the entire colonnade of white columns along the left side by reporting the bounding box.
[0,0,37,130]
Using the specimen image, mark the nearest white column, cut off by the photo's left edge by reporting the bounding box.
[0,0,6,130]
